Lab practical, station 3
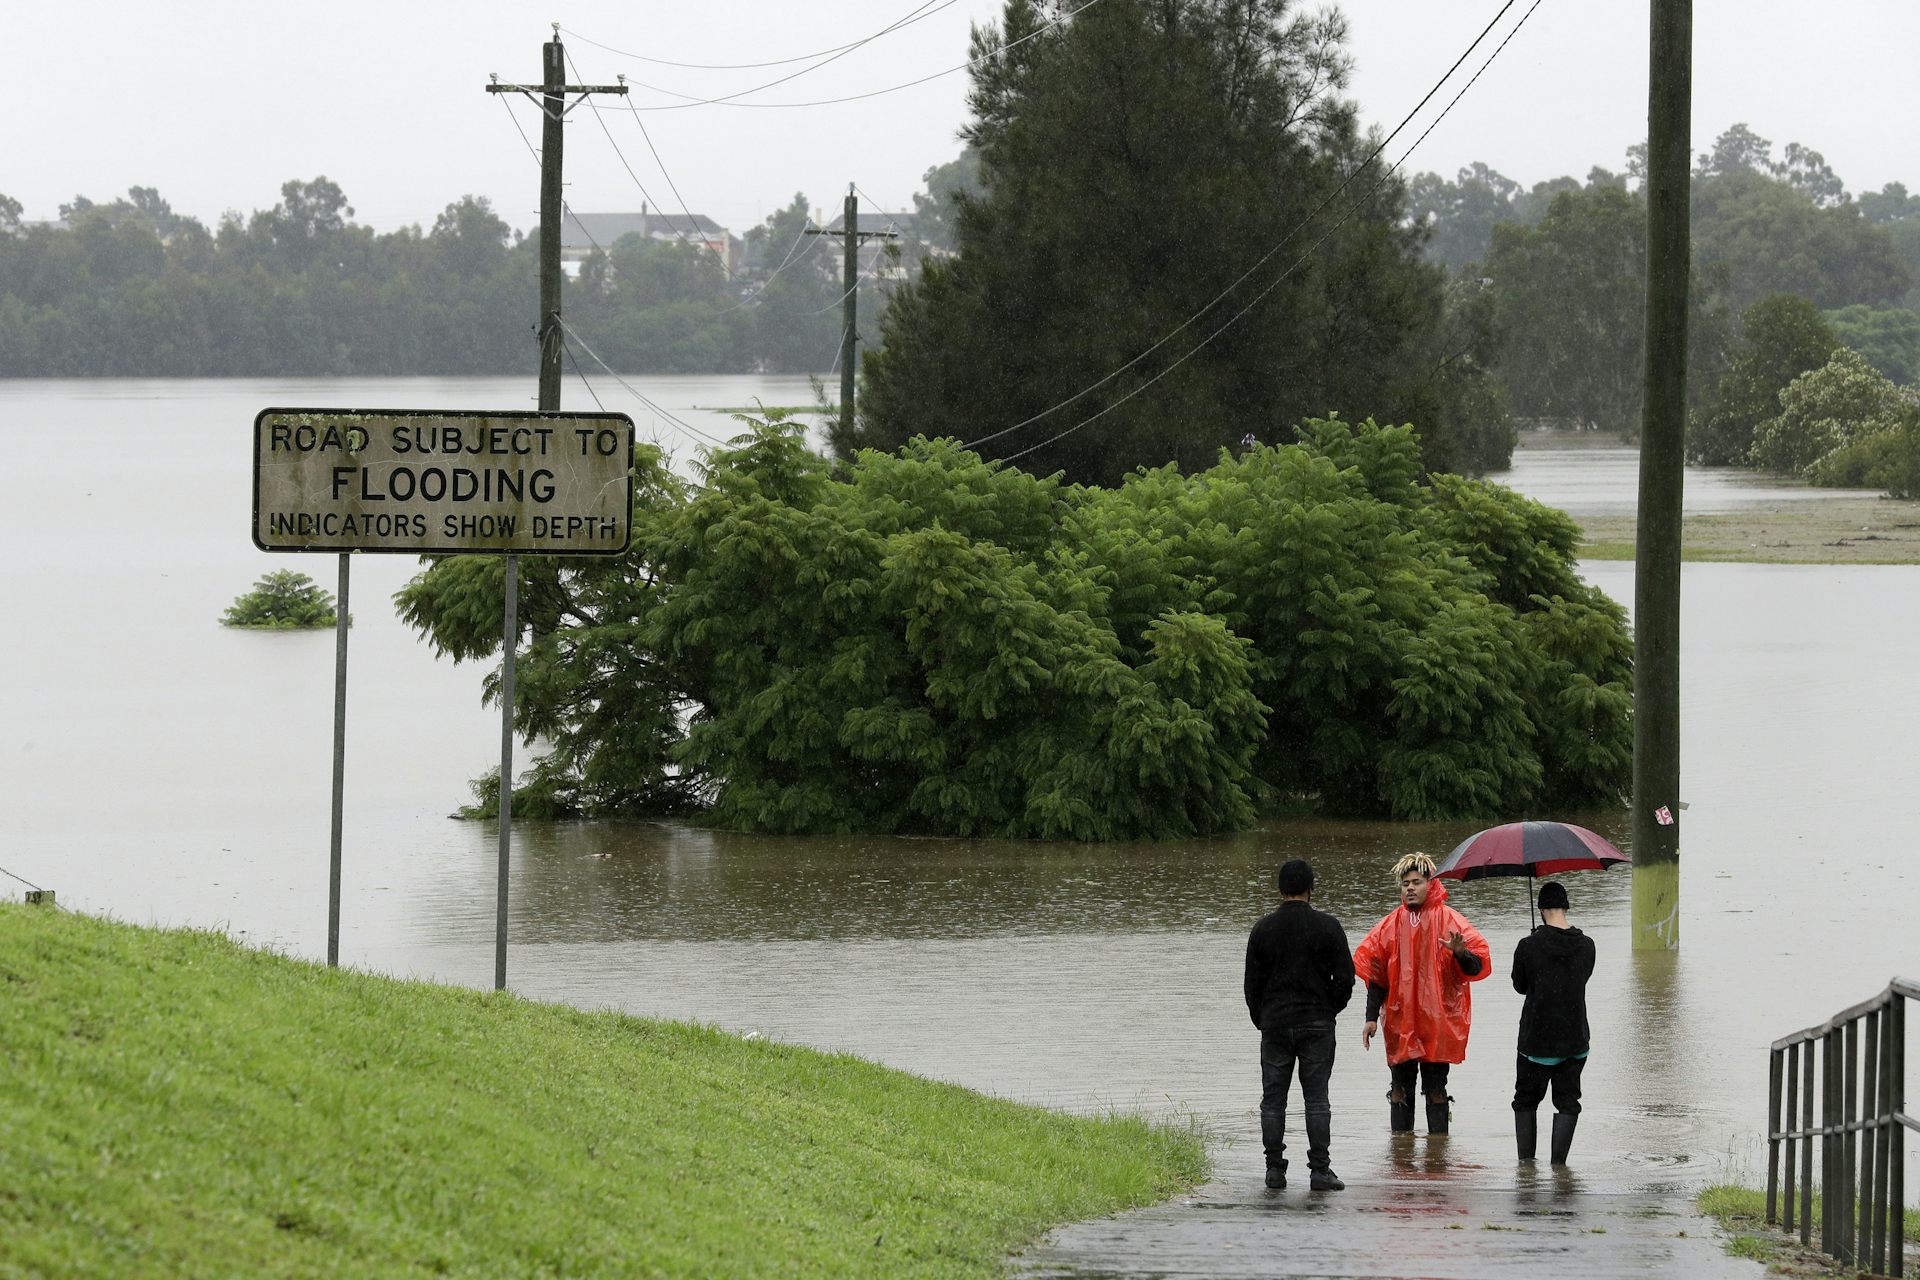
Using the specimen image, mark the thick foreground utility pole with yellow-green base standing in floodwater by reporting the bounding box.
[1634,0,1693,950]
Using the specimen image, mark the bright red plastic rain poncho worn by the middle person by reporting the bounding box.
[1354,881,1494,1065]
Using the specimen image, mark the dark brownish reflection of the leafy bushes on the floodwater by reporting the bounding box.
[472,814,1628,942]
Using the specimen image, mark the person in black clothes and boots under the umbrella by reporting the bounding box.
[1513,881,1594,1165]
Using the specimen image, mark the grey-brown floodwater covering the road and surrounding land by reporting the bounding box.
[0,378,1920,1188]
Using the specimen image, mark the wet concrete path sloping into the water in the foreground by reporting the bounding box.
[1012,1138,1764,1280]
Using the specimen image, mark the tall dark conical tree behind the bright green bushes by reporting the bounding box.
[856,0,1511,484]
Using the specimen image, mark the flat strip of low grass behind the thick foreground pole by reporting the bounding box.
[1578,497,1920,564]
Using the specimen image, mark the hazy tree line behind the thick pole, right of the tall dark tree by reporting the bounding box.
[1407,125,1920,445]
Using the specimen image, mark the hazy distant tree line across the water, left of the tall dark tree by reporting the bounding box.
[0,177,872,378]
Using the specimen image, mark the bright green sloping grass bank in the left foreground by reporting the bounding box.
[0,904,1206,1276]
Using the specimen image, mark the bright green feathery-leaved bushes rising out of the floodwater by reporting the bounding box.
[399,418,1632,839]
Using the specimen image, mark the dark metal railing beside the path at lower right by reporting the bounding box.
[1766,979,1920,1276]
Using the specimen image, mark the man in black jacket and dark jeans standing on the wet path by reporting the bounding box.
[1246,858,1354,1192]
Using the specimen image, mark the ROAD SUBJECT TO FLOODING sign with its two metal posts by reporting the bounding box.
[253,409,634,974]
